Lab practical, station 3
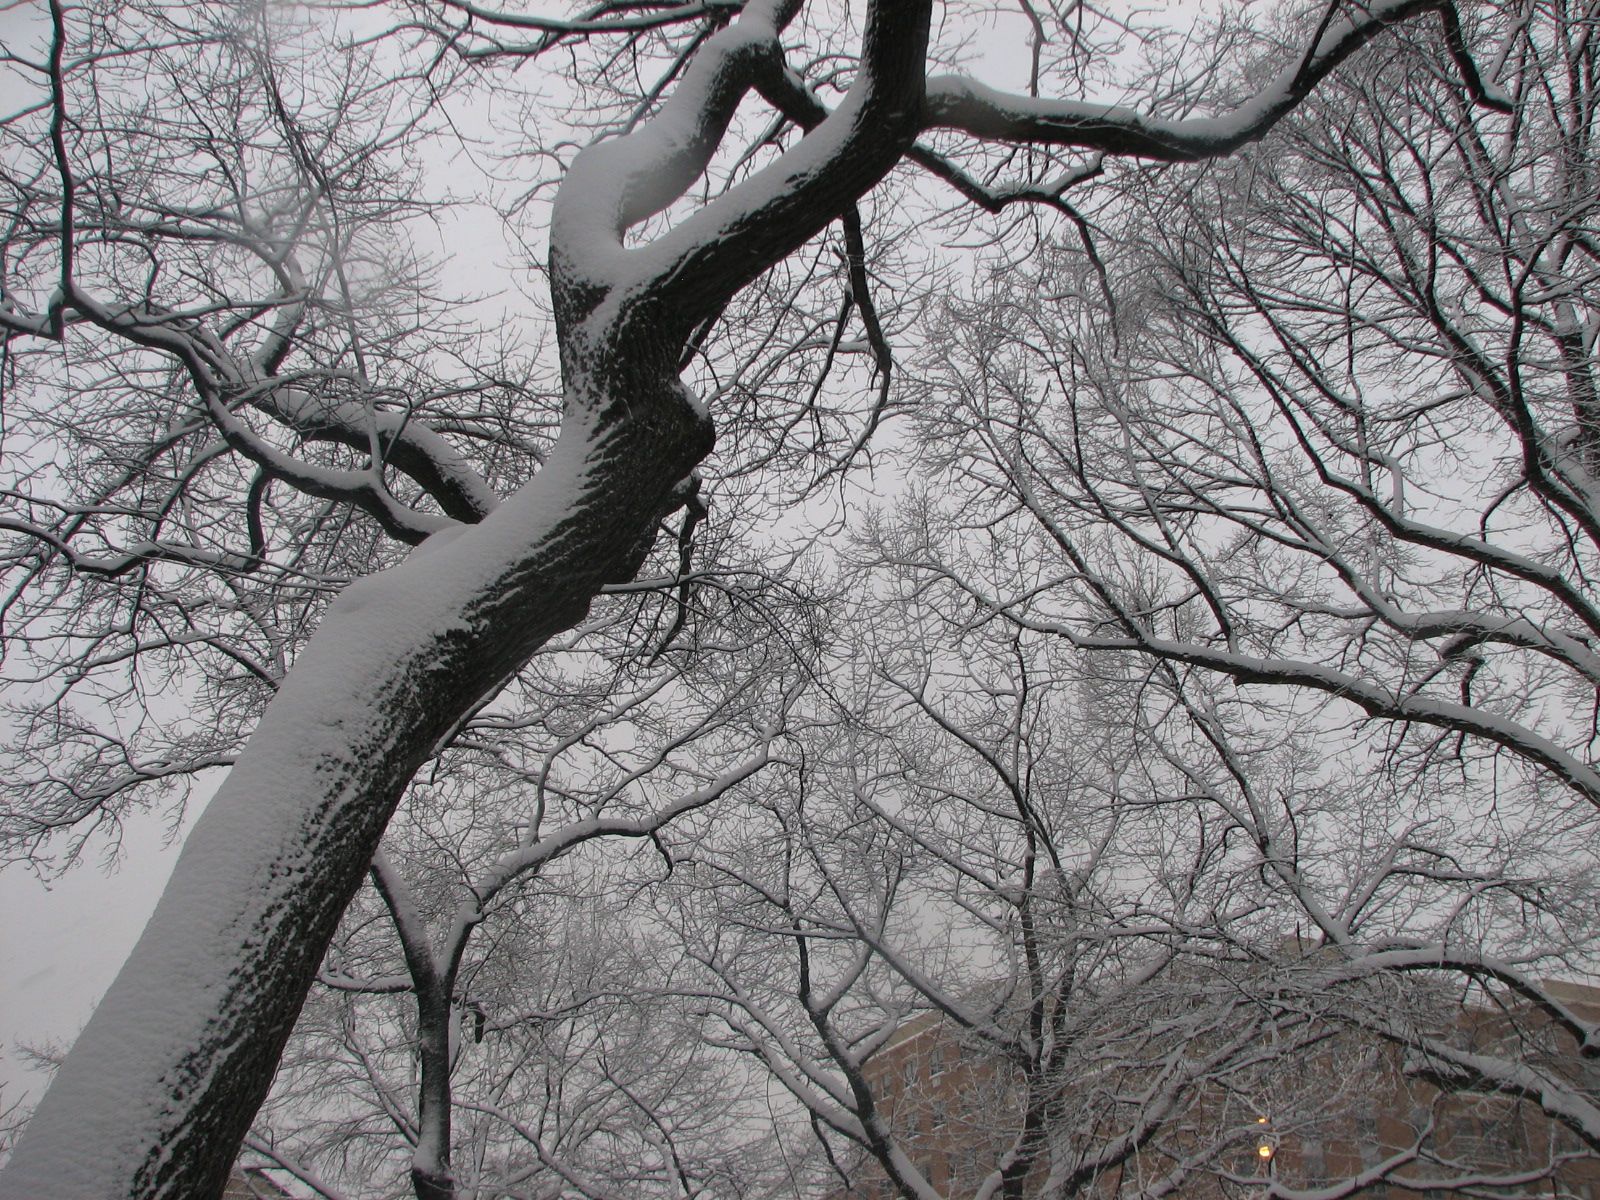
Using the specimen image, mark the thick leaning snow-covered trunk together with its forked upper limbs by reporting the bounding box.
[0,0,930,1200]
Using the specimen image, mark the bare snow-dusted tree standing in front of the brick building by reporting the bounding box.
[667,572,1600,1200]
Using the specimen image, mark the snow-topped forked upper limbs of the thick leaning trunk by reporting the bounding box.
[550,0,928,330]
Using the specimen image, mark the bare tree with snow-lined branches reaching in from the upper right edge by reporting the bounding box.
[864,5,1600,1184]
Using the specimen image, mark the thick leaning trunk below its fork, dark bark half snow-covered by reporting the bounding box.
[0,318,712,1200]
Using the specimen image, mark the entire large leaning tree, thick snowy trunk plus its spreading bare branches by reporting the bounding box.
[0,0,1510,1197]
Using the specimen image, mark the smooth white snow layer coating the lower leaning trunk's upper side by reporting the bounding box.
[0,414,592,1200]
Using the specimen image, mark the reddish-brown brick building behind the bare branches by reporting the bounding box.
[834,984,1600,1200]
